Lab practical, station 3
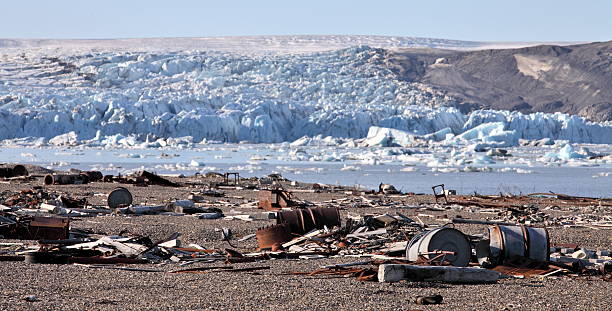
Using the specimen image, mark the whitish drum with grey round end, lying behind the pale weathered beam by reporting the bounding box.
[406,227,472,267]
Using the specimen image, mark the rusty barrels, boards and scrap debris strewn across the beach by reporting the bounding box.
[0,167,612,292]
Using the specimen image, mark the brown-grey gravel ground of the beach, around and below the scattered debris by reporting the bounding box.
[0,179,612,311]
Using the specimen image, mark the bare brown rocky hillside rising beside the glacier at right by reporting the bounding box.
[387,41,612,121]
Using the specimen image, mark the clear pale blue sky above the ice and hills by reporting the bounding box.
[0,0,612,42]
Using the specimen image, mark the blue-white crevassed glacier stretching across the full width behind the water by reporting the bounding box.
[0,46,612,147]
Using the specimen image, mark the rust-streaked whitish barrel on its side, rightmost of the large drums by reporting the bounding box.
[476,225,550,266]
